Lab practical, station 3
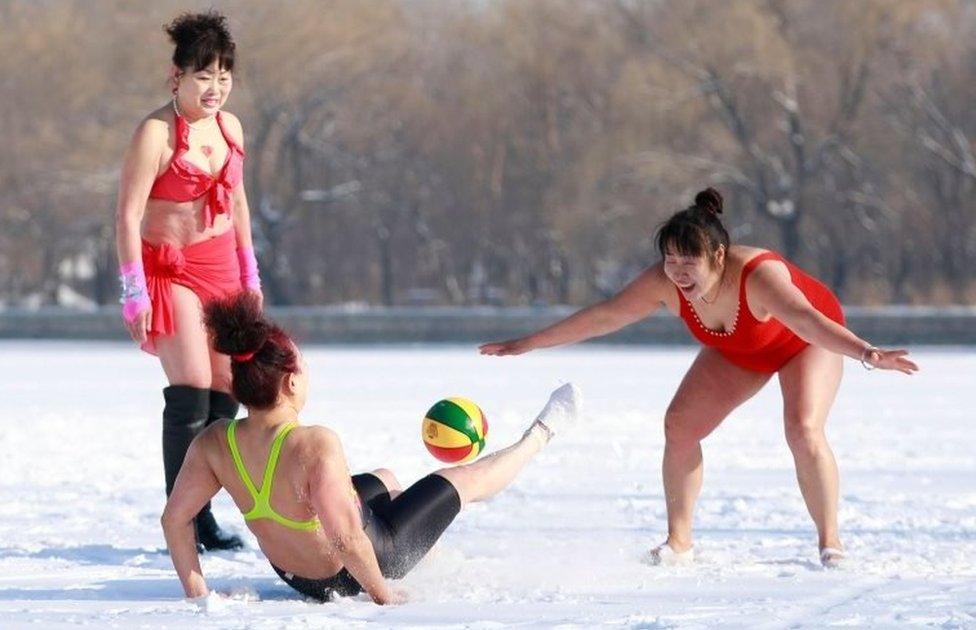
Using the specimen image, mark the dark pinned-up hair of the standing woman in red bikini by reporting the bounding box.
[165,10,236,72]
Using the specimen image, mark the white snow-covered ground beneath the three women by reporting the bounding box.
[0,342,976,629]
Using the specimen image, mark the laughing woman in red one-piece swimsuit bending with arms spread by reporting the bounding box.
[481,188,918,567]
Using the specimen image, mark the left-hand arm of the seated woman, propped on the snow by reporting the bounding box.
[161,435,220,599]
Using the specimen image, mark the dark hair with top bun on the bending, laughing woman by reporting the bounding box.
[657,188,729,258]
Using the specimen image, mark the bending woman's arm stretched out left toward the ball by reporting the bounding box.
[479,265,668,356]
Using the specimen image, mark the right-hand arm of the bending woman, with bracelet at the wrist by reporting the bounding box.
[746,262,918,374]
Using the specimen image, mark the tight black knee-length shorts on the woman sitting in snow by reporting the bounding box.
[271,473,461,601]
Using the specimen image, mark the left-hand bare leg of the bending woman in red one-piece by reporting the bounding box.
[662,348,771,552]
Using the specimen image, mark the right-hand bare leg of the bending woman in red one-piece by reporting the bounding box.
[779,346,844,549]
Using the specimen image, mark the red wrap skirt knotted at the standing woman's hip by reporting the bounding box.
[142,229,243,354]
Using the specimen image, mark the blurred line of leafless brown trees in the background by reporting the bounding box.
[0,0,976,305]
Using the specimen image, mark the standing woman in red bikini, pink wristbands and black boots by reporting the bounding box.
[116,12,261,549]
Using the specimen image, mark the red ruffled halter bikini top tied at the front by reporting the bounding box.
[149,111,244,227]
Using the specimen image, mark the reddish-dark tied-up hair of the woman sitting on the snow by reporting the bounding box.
[204,291,300,409]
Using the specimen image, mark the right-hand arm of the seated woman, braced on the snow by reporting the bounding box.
[308,429,397,604]
